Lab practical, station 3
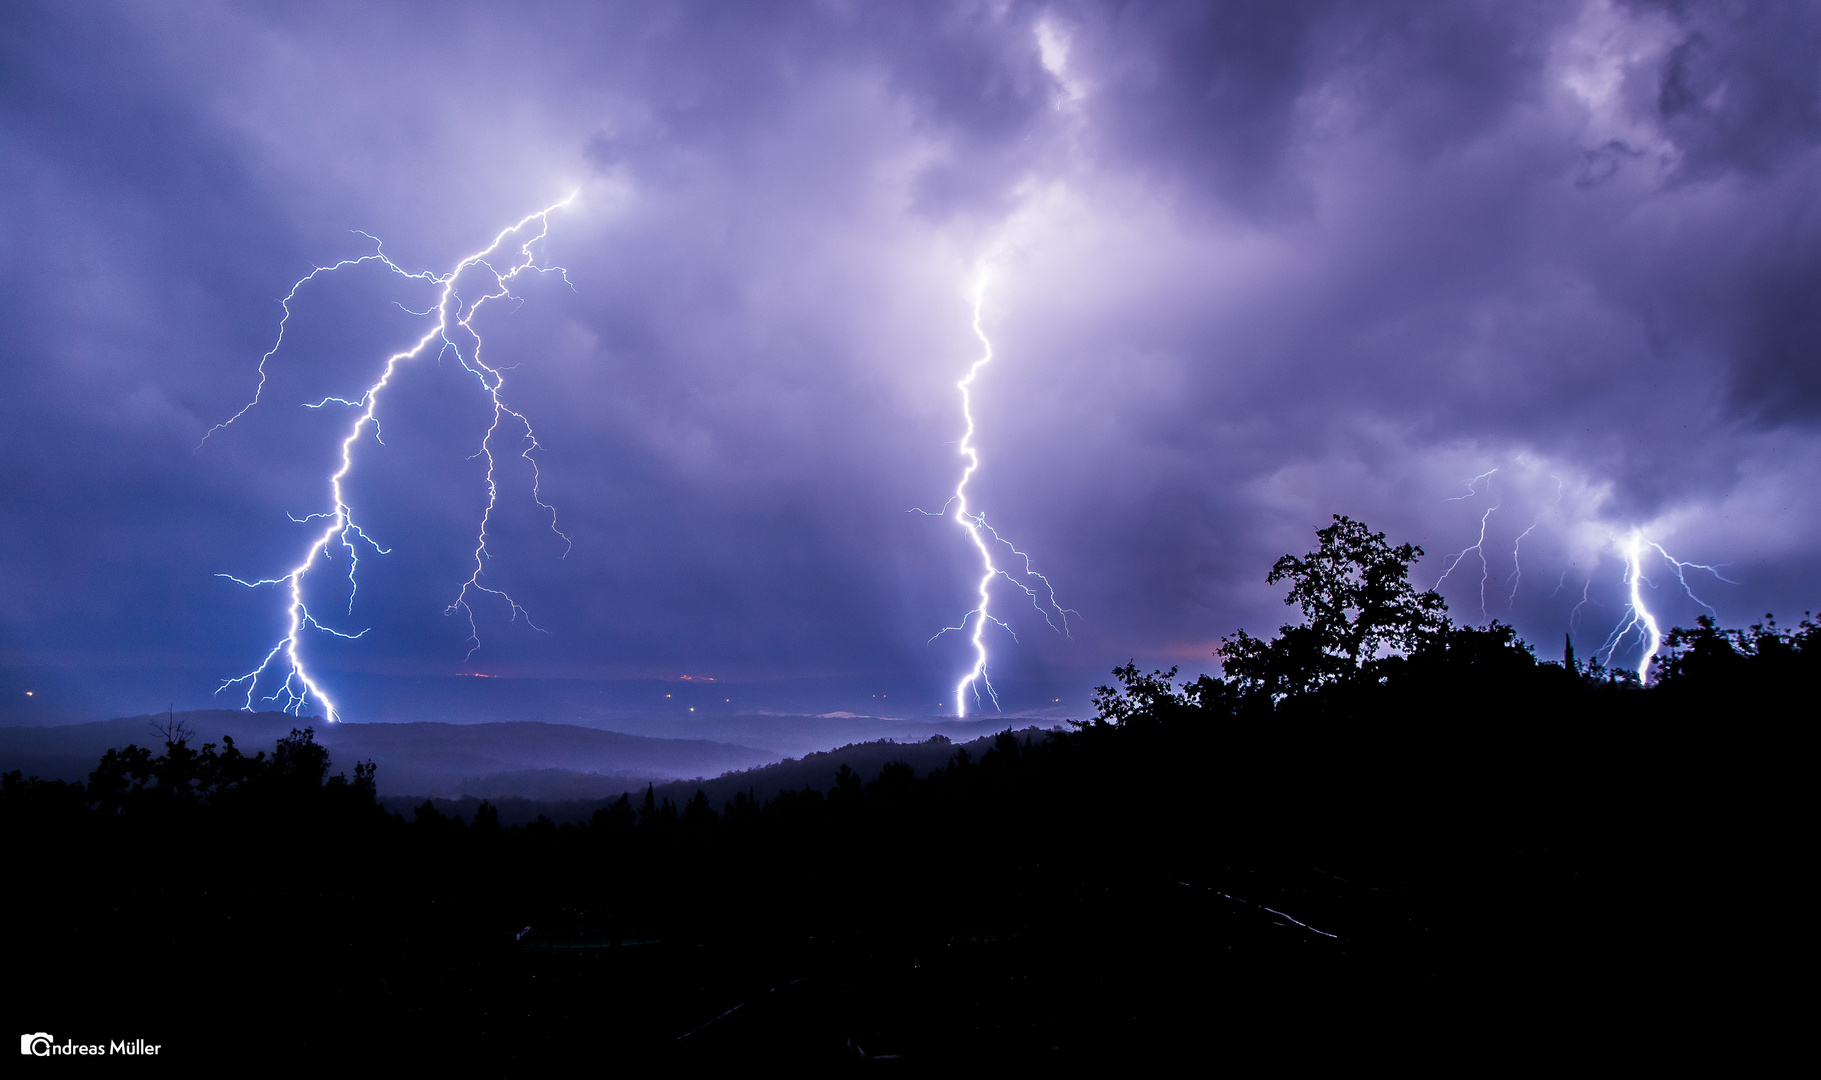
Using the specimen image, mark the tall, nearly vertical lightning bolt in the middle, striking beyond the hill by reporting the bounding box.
[911,273,1080,718]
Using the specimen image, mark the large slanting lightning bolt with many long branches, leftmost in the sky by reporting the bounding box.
[197,193,577,723]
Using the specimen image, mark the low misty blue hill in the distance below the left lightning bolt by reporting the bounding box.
[0,710,778,798]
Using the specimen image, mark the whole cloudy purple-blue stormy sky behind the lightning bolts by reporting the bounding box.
[0,2,1821,719]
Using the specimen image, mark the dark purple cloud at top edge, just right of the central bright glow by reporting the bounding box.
[1062,4,1564,211]
